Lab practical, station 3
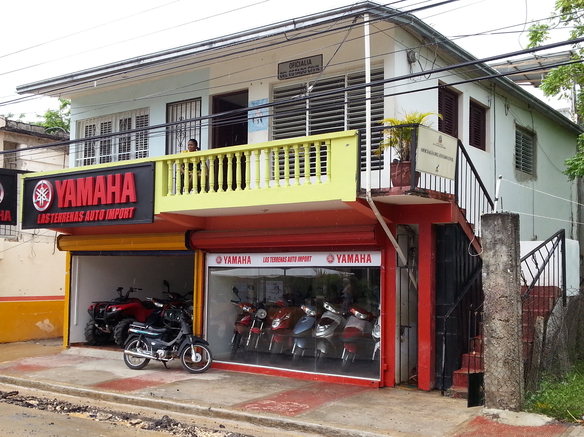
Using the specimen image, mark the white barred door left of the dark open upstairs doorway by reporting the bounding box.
[166,99,201,154]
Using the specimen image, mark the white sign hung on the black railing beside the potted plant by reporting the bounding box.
[416,126,458,179]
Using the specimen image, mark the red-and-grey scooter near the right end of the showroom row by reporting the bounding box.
[341,306,374,371]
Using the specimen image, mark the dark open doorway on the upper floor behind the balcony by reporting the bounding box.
[211,90,248,149]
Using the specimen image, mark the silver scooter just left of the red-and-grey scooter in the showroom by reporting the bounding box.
[312,302,345,369]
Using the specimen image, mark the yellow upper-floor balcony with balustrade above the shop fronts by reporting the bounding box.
[21,124,493,240]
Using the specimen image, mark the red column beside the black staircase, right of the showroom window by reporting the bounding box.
[418,223,436,390]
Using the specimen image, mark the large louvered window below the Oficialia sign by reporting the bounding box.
[272,68,384,169]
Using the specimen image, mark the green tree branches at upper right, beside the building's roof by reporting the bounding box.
[528,0,584,179]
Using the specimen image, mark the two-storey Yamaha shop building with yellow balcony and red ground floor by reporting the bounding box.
[18,2,581,390]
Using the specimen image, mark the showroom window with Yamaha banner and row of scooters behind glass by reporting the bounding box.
[206,252,381,379]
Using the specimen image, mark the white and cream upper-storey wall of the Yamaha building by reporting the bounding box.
[67,18,581,244]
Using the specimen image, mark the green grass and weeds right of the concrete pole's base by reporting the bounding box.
[524,361,584,422]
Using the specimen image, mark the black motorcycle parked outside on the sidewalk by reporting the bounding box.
[124,299,213,373]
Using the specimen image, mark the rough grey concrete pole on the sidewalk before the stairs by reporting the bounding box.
[481,213,524,411]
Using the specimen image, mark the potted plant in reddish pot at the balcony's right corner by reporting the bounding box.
[375,111,440,187]
